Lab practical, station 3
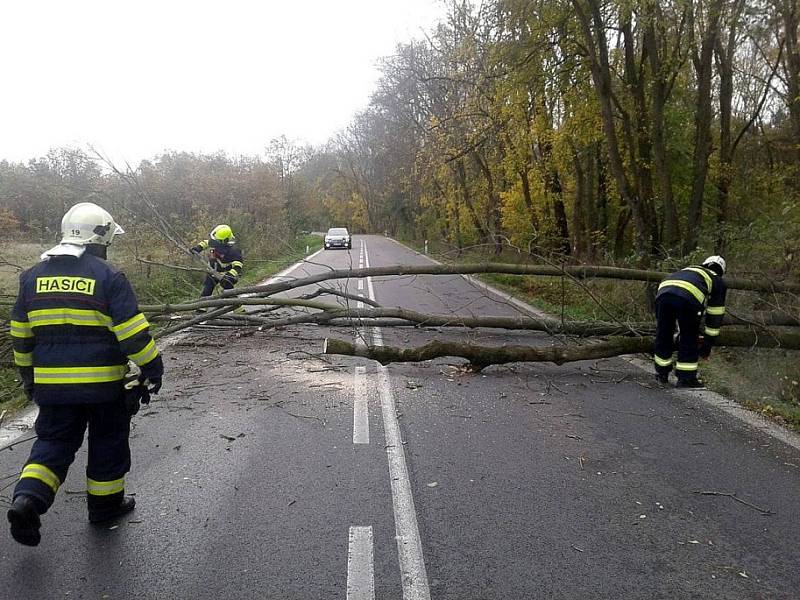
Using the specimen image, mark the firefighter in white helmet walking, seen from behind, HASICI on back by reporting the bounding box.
[8,202,164,546]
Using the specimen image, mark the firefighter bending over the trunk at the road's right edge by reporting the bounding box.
[653,256,728,388]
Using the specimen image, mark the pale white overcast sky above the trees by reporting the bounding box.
[0,0,444,163]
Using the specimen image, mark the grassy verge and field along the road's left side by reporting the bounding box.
[0,234,322,414]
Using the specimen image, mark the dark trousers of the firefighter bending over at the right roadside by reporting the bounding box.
[653,294,702,380]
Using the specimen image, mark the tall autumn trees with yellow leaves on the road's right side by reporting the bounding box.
[316,0,800,272]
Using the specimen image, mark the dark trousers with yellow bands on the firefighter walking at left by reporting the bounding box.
[14,401,131,513]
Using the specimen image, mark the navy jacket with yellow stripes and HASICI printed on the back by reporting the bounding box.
[11,252,164,405]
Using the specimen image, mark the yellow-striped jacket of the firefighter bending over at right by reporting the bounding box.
[656,267,728,342]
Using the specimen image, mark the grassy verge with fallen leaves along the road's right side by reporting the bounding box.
[404,241,800,431]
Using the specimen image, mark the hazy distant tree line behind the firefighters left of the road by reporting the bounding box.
[0,143,324,256]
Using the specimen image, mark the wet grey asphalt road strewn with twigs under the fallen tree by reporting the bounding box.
[0,236,800,600]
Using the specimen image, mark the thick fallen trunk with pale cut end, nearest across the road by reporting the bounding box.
[323,330,800,371]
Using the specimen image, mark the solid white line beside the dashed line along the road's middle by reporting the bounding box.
[364,244,431,600]
